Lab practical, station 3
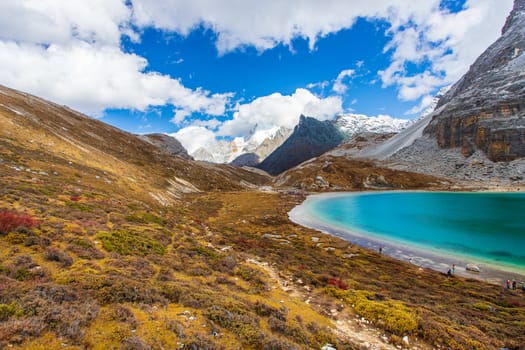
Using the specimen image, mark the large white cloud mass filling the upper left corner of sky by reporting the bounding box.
[0,0,232,116]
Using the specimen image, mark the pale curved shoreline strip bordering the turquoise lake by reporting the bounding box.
[288,191,525,286]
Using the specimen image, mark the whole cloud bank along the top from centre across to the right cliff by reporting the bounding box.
[133,0,512,100]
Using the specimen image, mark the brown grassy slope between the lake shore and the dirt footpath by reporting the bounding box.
[200,193,525,349]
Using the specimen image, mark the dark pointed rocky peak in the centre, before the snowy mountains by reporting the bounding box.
[258,115,344,175]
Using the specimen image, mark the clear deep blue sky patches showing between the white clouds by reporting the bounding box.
[108,19,408,132]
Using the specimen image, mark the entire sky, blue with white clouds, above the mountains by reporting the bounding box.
[0,0,512,148]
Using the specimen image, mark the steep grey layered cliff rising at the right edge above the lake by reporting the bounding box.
[425,0,525,161]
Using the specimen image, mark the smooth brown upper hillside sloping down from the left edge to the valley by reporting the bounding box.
[0,87,268,204]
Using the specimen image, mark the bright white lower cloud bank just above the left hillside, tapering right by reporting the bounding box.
[0,41,231,116]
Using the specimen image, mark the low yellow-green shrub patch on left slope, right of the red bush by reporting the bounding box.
[98,230,166,256]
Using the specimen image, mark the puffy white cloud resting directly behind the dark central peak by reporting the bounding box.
[218,89,343,136]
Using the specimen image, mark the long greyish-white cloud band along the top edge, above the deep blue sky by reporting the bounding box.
[132,0,439,53]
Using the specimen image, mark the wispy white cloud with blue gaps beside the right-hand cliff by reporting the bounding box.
[379,0,512,103]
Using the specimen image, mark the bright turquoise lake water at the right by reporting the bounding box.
[308,192,525,271]
